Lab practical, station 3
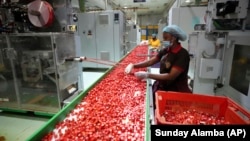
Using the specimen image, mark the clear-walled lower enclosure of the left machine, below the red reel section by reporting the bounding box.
[0,33,79,113]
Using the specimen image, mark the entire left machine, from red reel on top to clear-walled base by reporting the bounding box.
[0,0,83,114]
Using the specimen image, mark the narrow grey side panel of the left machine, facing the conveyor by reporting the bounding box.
[54,34,78,104]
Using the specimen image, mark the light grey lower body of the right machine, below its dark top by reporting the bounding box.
[189,31,250,109]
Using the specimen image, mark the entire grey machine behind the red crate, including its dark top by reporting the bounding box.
[188,0,250,109]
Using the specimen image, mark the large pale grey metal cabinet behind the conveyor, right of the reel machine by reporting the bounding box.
[78,10,126,68]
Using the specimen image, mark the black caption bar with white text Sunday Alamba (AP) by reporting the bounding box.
[151,125,250,141]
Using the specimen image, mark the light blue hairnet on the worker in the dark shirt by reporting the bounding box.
[162,25,187,41]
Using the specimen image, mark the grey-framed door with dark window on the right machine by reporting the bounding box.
[216,31,250,110]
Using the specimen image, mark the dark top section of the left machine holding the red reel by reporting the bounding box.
[0,0,78,33]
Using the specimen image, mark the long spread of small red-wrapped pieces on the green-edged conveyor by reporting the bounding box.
[42,46,148,141]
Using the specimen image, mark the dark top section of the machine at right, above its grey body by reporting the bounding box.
[205,0,250,32]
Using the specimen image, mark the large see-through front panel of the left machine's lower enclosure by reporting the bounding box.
[9,34,60,112]
